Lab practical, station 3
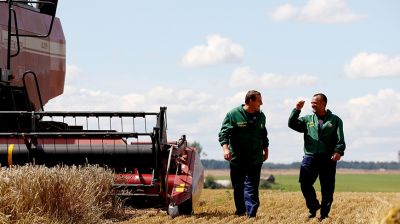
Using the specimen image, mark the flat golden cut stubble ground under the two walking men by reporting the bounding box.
[121,189,400,224]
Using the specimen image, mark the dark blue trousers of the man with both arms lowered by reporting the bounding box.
[230,163,262,217]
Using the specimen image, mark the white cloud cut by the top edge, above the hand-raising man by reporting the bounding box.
[270,0,365,23]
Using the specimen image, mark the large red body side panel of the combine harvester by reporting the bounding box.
[0,2,66,109]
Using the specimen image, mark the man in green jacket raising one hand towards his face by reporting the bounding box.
[289,93,346,220]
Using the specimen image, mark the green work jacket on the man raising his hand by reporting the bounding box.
[288,109,346,156]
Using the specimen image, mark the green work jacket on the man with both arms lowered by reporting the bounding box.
[219,105,269,165]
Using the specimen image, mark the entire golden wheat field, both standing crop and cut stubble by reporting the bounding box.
[0,166,400,224]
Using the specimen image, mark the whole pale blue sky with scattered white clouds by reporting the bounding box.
[45,0,400,163]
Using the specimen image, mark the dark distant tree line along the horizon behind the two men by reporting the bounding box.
[201,159,400,170]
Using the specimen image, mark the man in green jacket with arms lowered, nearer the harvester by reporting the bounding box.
[219,90,269,217]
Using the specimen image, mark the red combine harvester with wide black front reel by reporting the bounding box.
[0,0,204,216]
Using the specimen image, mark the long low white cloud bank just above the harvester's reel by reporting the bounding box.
[46,85,219,113]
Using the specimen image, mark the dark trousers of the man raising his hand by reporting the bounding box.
[299,154,336,216]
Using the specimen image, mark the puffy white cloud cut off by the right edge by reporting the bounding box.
[345,52,400,78]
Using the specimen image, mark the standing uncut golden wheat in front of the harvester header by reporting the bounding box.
[0,166,121,223]
